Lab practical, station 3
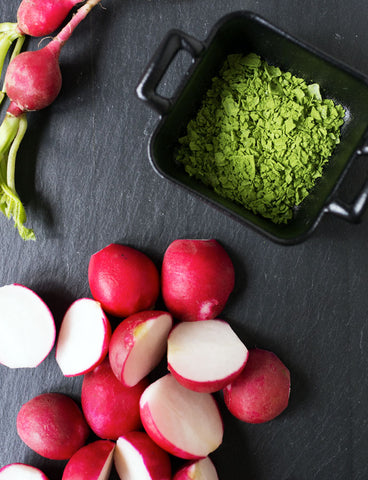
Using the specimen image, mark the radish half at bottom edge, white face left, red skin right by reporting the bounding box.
[114,432,171,480]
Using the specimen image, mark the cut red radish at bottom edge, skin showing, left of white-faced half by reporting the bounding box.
[61,440,115,480]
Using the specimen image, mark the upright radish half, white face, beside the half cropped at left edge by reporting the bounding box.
[56,298,111,377]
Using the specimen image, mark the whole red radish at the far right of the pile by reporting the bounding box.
[223,348,290,423]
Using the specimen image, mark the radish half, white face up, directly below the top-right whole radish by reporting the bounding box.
[167,319,248,392]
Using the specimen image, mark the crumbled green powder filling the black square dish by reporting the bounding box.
[177,54,345,223]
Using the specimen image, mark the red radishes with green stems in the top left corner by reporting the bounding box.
[0,0,101,240]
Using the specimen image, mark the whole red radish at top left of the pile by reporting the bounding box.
[88,243,160,317]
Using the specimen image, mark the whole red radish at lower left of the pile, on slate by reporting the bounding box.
[17,393,90,460]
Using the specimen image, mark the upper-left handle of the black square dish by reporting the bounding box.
[136,29,204,115]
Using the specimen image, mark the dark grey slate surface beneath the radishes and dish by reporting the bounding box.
[0,0,368,480]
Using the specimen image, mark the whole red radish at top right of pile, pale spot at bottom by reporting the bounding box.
[161,240,235,321]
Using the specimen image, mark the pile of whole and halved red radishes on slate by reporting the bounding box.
[0,239,290,480]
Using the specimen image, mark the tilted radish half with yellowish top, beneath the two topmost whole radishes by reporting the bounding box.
[109,310,173,387]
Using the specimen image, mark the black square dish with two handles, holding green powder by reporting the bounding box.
[137,11,368,244]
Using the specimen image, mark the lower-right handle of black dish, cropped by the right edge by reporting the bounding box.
[325,146,368,223]
